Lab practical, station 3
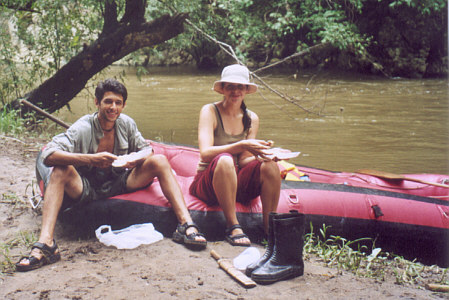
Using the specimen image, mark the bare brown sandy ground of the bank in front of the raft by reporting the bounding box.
[0,136,449,299]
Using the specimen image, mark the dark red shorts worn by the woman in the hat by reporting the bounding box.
[190,153,262,206]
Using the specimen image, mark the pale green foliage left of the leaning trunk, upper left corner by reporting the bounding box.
[0,0,102,105]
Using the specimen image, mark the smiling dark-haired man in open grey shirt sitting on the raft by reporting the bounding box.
[16,79,207,272]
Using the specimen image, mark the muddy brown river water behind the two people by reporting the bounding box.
[58,67,449,174]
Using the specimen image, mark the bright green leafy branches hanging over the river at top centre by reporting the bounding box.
[154,0,384,65]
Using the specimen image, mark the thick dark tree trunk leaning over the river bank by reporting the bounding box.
[11,11,187,113]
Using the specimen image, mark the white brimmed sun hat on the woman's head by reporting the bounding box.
[213,64,257,94]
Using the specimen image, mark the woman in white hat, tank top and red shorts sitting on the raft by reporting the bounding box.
[190,65,281,246]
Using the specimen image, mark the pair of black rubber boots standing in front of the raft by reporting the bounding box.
[245,211,305,284]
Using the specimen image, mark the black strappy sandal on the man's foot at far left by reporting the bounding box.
[16,240,61,272]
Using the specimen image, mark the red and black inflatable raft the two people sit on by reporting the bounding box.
[37,141,449,266]
